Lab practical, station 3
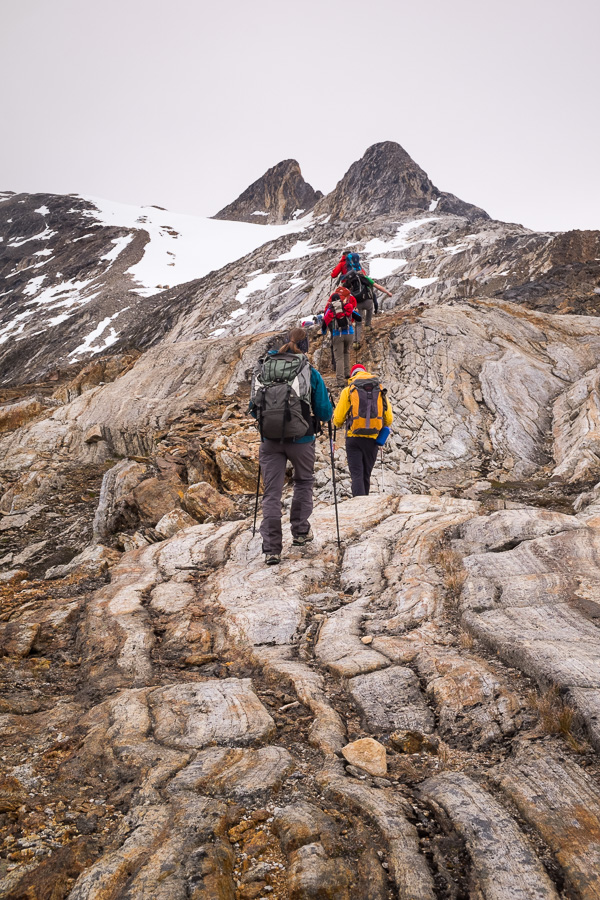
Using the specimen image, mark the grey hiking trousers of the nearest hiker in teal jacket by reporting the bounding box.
[258,440,315,553]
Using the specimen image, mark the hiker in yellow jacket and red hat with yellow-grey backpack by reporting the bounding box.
[333,365,394,497]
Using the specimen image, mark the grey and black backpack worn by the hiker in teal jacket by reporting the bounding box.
[250,353,315,443]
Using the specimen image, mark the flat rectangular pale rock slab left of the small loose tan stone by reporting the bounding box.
[148,678,275,750]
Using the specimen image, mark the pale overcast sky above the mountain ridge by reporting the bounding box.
[0,0,600,230]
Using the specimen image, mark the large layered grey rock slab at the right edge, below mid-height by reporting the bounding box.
[461,527,600,747]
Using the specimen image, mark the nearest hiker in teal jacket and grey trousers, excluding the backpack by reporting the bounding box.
[251,328,333,566]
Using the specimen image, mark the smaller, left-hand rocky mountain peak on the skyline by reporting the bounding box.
[213,159,323,225]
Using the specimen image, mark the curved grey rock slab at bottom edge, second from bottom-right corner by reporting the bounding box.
[421,772,559,900]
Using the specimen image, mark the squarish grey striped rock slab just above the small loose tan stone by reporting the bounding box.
[348,666,434,733]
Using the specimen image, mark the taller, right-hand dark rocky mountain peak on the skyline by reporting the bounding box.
[315,141,489,221]
